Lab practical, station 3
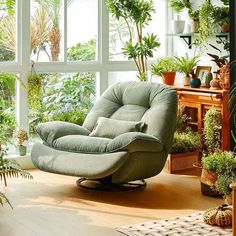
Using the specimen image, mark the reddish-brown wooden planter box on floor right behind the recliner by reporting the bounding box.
[167,151,199,174]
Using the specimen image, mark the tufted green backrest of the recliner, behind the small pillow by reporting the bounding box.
[83,82,177,152]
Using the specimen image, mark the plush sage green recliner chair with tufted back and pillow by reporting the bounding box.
[31,82,177,189]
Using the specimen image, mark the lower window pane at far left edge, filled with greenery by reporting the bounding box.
[0,74,16,144]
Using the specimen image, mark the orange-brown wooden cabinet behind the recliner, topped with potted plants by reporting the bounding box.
[174,86,230,150]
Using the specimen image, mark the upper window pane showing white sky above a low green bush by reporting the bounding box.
[67,0,98,61]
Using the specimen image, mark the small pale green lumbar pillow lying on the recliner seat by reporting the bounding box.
[89,117,145,139]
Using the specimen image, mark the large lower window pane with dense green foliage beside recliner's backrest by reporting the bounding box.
[29,73,96,133]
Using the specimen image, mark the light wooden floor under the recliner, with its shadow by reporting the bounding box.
[0,170,222,236]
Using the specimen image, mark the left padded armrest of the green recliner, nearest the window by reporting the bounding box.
[35,121,90,146]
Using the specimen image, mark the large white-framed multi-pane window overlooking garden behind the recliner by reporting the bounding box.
[0,0,166,147]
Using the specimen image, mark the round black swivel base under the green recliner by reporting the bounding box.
[76,176,146,192]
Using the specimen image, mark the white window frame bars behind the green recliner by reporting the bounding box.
[0,0,171,131]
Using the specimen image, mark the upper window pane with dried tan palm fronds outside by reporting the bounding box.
[30,0,64,62]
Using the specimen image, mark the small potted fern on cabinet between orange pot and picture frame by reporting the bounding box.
[175,54,199,86]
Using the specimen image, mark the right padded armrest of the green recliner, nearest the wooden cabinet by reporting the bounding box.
[107,132,163,153]
